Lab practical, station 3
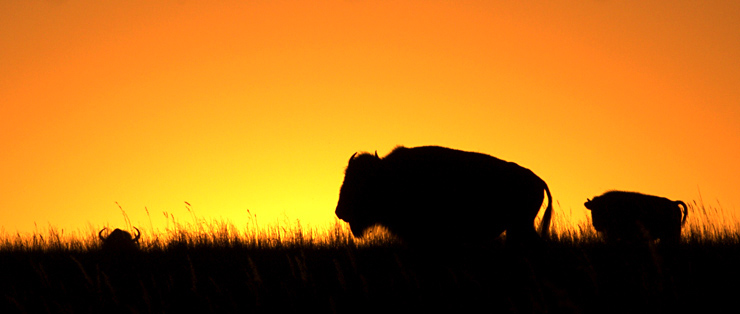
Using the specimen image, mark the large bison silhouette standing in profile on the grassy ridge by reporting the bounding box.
[336,146,552,244]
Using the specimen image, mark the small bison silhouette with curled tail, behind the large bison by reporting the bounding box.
[584,191,689,244]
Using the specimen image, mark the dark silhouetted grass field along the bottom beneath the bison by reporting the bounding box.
[0,202,740,313]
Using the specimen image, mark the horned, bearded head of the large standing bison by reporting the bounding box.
[335,152,382,237]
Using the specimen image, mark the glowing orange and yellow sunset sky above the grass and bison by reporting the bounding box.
[0,1,740,233]
